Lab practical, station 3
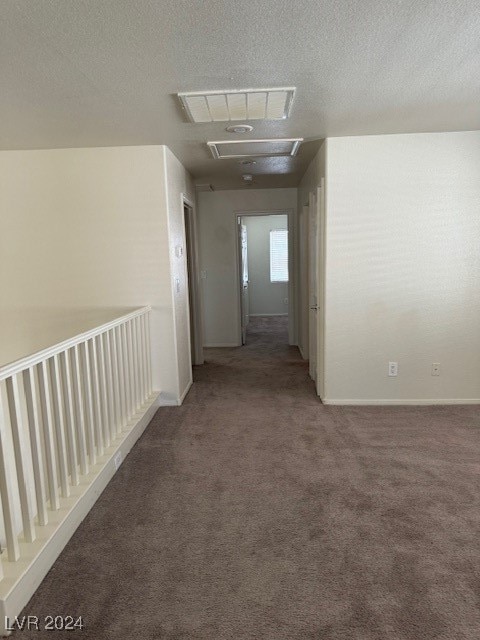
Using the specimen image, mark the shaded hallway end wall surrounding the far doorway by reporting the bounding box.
[198,189,297,346]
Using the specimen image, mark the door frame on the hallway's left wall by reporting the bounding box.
[181,193,204,365]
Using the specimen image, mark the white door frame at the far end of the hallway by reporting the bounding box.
[233,209,297,346]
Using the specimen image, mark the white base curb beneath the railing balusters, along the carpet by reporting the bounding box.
[0,391,160,636]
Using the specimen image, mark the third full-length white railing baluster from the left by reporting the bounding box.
[38,360,60,511]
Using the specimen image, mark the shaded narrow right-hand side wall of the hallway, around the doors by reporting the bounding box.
[297,141,326,359]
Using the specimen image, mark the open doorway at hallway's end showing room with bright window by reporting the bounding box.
[237,212,293,345]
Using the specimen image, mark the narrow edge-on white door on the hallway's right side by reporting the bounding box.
[308,193,318,381]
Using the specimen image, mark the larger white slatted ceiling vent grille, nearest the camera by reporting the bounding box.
[178,87,295,122]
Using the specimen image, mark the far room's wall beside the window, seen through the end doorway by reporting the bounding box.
[242,215,288,315]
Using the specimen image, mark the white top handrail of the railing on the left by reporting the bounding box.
[0,306,151,380]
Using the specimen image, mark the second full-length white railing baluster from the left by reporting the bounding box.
[23,367,48,526]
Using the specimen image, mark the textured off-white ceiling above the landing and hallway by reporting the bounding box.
[0,0,480,188]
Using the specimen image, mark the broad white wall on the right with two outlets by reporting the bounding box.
[325,132,480,403]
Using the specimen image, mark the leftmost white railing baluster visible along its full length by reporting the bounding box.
[6,373,36,542]
